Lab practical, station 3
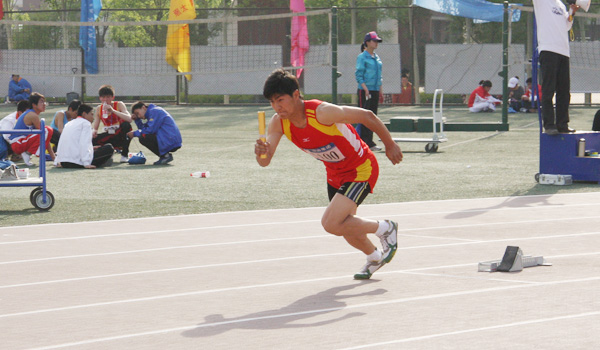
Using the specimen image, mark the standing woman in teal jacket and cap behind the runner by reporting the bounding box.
[354,32,383,151]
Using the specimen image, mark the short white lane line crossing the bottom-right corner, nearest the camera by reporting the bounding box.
[343,311,600,350]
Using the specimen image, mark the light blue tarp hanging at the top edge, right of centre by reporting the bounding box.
[413,0,521,22]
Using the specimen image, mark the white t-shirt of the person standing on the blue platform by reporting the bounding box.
[533,0,573,57]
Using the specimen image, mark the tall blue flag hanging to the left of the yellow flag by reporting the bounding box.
[79,0,102,74]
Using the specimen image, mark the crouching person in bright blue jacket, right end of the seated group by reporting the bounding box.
[127,101,182,165]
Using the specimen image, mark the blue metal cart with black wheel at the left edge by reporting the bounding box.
[0,119,54,210]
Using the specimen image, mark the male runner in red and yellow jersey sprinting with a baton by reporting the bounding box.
[254,69,402,279]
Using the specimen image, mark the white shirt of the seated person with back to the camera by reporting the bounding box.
[54,117,94,166]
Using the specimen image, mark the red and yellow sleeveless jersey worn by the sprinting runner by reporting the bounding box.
[281,100,379,191]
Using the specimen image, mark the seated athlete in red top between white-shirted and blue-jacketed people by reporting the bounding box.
[92,85,133,163]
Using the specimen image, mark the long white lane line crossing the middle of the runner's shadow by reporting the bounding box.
[23,277,600,350]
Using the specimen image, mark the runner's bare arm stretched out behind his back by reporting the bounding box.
[316,102,402,164]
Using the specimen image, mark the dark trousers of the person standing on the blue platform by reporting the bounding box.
[540,51,571,129]
